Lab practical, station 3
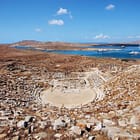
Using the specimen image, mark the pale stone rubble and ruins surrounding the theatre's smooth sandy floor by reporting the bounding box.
[0,45,140,140]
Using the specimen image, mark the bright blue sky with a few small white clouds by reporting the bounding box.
[0,0,140,43]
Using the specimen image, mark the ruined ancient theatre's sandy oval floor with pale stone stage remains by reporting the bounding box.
[40,68,110,108]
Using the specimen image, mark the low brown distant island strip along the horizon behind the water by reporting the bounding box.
[10,40,140,50]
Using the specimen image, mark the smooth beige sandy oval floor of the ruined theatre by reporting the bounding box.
[40,88,96,108]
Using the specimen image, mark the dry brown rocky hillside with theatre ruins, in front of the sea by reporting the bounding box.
[0,44,140,140]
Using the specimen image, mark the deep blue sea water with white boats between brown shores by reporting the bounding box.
[16,46,140,59]
